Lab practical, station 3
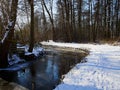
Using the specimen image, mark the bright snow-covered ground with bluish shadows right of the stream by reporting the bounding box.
[41,41,120,90]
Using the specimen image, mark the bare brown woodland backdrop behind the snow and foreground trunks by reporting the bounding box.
[0,0,120,43]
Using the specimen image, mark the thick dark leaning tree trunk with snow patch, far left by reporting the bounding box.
[0,0,18,68]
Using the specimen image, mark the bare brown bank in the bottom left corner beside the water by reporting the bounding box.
[0,78,28,90]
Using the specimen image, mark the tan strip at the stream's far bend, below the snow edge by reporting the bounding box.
[42,45,89,57]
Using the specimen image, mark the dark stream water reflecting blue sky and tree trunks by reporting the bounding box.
[0,50,86,90]
